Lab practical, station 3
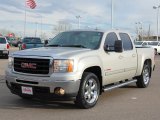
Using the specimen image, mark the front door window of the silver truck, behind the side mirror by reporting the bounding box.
[104,32,118,51]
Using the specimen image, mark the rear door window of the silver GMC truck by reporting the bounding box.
[119,33,133,51]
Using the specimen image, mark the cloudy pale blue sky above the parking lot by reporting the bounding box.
[0,0,160,36]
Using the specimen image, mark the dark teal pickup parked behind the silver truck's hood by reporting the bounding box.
[19,37,44,50]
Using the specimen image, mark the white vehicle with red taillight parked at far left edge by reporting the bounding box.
[0,36,9,59]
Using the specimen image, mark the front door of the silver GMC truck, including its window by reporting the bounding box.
[102,32,126,85]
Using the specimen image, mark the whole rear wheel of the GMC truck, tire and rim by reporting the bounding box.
[136,62,151,88]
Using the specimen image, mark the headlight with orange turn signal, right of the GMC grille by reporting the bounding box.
[53,60,73,73]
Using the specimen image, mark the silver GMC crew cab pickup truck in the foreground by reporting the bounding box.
[6,30,155,108]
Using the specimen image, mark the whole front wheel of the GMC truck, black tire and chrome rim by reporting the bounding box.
[75,72,100,109]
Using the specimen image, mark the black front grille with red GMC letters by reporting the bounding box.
[14,58,50,74]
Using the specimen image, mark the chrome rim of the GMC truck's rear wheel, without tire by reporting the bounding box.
[143,66,150,84]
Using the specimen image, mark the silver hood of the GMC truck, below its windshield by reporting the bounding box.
[12,47,91,58]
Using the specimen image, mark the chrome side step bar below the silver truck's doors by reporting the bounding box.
[103,79,137,92]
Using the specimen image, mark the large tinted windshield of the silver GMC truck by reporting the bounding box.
[48,31,103,49]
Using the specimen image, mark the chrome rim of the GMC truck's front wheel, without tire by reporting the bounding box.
[84,78,98,103]
